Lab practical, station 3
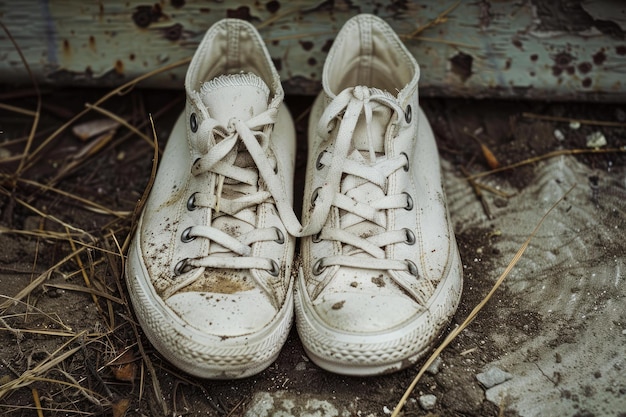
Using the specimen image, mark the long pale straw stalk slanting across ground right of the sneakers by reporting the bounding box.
[391,184,576,417]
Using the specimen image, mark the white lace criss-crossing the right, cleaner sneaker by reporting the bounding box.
[305,86,417,275]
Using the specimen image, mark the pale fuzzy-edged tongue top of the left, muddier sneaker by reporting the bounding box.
[200,73,270,126]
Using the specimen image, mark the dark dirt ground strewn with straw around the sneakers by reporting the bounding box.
[0,88,626,417]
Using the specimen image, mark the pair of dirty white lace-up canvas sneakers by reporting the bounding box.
[126,15,462,379]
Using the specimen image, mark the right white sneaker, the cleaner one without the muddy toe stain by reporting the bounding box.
[295,15,462,375]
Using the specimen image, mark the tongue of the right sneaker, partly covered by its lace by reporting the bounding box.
[352,88,395,156]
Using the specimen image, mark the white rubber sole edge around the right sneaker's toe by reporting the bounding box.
[295,244,463,376]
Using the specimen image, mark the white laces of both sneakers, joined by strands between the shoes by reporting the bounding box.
[170,87,416,292]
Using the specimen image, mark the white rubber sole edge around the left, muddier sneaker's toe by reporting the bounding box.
[126,224,294,379]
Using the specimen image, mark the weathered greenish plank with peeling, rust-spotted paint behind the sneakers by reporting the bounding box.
[0,0,626,100]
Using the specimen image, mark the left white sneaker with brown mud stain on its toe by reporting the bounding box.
[126,19,295,378]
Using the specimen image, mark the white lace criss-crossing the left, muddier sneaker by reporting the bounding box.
[170,109,286,292]
